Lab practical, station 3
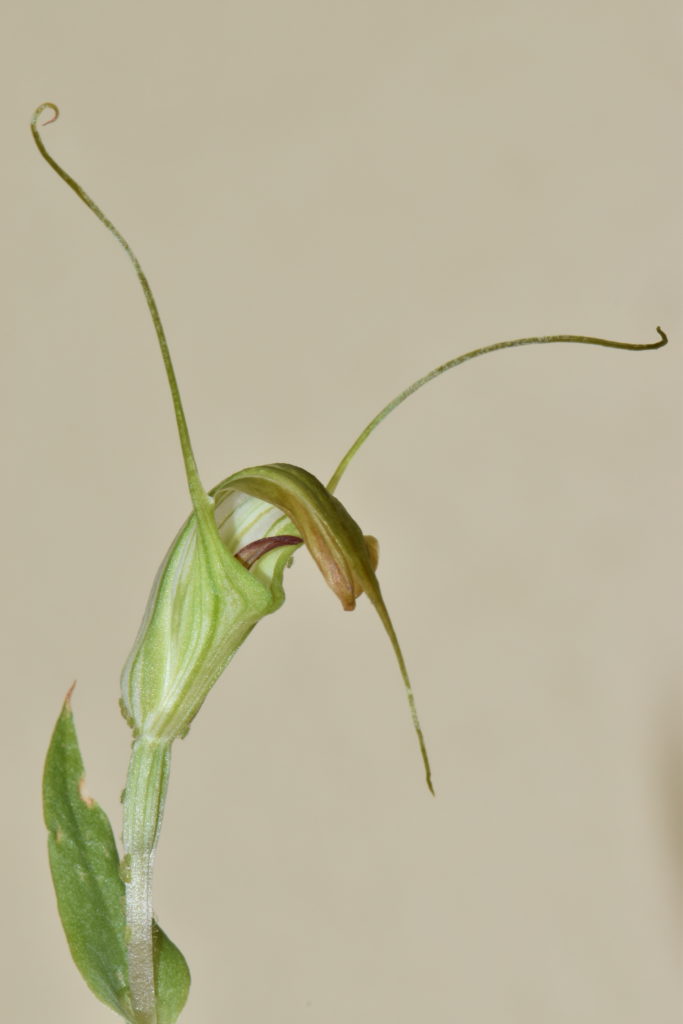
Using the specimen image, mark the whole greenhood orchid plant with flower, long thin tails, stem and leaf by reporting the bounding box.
[31,103,667,1024]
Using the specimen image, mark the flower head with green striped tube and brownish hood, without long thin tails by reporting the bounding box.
[121,463,394,740]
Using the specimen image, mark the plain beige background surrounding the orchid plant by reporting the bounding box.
[0,0,683,1024]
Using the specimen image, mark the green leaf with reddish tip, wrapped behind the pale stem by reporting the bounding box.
[43,691,189,1024]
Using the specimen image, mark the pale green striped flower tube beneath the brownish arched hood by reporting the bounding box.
[121,496,300,740]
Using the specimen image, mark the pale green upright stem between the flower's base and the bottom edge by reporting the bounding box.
[123,737,171,1024]
